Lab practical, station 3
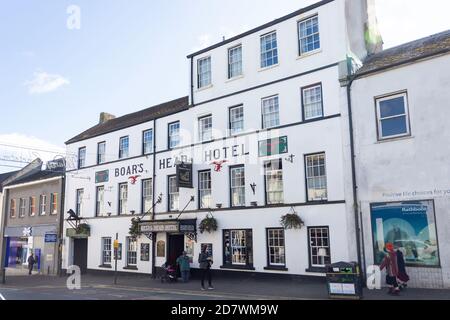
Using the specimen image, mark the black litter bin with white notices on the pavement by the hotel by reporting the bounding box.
[326,262,362,299]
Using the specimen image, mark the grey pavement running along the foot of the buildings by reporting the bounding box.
[0,275,450,300]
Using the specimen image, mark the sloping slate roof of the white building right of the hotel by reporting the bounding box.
[356,30,450,76]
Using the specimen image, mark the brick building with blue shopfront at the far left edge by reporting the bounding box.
[2,159,64,275]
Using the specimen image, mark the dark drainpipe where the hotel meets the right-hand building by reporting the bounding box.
[346,62,365,286]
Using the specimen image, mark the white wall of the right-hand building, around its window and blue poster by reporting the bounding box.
[352,54,450,288]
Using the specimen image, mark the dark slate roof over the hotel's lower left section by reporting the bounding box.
[66,97,189,144]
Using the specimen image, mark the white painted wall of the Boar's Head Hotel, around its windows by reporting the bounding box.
[63,0,380,275]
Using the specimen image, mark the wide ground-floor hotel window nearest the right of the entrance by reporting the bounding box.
[223,229,253,267]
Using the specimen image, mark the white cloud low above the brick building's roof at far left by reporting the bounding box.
[0,133,66,173]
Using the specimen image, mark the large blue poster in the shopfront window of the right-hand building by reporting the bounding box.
[371,200,439,267]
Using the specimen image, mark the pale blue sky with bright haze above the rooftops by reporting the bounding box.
[0,0,450,172]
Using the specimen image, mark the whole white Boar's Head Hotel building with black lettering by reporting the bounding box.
[63,0,378,275]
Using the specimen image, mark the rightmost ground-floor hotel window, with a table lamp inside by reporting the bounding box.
[308,227,331,267]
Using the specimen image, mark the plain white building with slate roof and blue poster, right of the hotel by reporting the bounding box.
[351,30,450,288]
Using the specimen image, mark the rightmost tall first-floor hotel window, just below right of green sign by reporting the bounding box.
[305,152,328,202]
